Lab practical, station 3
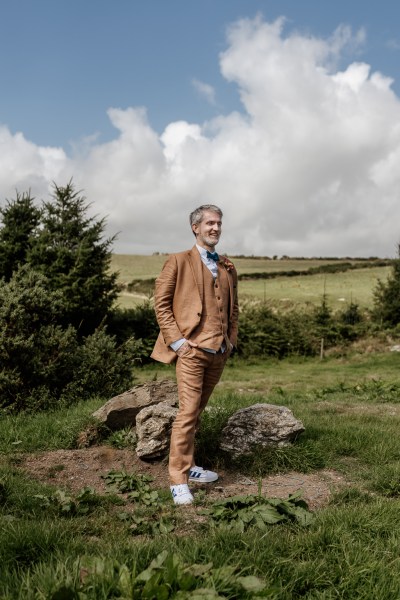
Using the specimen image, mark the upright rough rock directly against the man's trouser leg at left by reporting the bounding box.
[136,402,178,458]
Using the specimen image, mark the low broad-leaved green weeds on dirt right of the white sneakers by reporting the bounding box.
[206,493,313,532]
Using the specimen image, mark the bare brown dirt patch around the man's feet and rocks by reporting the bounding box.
[19,446,348,510]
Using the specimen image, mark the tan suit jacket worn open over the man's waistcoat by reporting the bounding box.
[151,246,239,363]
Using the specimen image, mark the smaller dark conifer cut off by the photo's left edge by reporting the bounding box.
[0,192,41,281]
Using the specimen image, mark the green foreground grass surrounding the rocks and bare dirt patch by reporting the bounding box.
[0,353,400,600]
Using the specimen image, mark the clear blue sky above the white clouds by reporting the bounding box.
[0,0,400,151]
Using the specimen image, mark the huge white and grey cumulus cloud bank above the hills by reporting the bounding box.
[0,17,400,256]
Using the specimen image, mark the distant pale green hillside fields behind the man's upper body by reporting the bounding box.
[111,254,390,309]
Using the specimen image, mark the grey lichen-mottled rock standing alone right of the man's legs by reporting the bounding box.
[220,404,304,458]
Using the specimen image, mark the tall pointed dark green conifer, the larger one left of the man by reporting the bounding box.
[28,182,118,336]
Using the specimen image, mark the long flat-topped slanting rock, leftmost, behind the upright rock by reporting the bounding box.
[93,379,178,430]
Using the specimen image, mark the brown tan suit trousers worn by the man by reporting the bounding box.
[169,348,228,485]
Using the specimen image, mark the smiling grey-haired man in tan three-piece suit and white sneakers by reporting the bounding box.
[151,204,239,504]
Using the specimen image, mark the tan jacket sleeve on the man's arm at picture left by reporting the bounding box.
[154,255,184,346]
